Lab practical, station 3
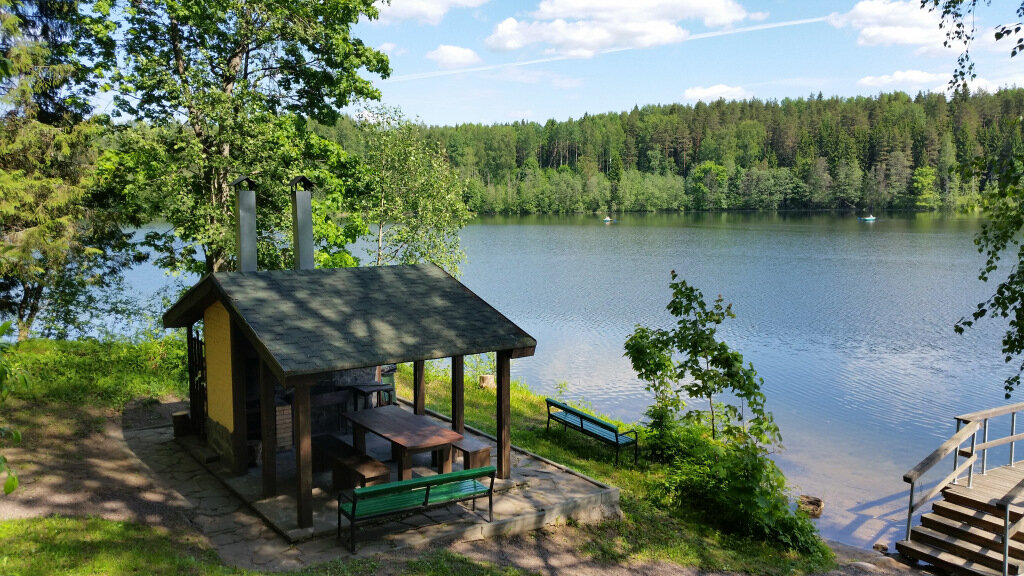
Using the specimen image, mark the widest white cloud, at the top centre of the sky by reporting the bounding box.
[486,0,749,57]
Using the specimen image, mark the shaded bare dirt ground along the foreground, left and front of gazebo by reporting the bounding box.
[0,401,923,576]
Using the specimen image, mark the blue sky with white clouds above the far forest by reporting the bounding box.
[353,0,1024,125]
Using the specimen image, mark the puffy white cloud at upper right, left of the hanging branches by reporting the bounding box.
[828,0,945,53]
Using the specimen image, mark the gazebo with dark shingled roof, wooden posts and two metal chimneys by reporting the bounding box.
[163,183,537,528]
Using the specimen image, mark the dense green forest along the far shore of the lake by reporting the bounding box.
[317,89,1024,214]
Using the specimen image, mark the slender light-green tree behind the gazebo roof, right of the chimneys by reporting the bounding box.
[353,107,469,276]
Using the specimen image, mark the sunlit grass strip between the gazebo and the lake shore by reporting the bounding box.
[395,356,835,575]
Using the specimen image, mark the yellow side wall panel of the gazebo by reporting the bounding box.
[203,301,234,433]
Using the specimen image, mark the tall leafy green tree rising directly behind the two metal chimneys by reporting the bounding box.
[115,0,390,274]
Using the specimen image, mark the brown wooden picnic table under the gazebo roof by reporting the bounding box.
[344,405,463,480]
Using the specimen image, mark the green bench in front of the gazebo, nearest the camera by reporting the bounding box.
[338,466,497,554]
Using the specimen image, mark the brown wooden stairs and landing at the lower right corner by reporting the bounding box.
[896,466,1024,576]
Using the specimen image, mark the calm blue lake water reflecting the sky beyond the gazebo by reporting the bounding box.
[129,213,1010,546]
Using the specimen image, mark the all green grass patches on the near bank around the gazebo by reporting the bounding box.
[0,338,833,576]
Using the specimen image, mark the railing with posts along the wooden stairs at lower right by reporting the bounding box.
[903,403,1024,576]
